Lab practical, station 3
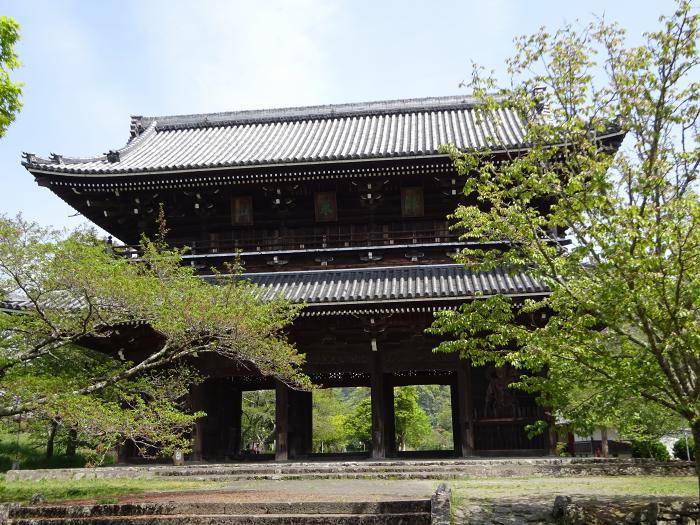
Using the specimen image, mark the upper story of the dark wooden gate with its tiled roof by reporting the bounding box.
[24,96,596,272]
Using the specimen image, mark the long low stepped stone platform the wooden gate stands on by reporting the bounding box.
[5,457,695,481]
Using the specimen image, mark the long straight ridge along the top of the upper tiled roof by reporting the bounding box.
[132,95,500,130]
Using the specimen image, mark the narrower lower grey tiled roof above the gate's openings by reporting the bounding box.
[221,264,549,305]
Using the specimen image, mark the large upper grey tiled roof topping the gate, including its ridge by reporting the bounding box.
[24,96,524,174]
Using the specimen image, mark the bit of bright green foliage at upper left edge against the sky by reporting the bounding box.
[0,16,22,138]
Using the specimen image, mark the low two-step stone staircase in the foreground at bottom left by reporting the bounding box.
[0,500,434,525]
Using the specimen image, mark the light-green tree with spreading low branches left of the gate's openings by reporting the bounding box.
[0,217,310,460]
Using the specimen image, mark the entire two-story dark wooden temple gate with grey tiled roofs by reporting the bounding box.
[24,96,604,460]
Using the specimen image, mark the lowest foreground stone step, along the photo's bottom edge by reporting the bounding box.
[7,512,431,525]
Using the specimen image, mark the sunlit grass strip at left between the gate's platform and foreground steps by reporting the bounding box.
[0,479,223,503]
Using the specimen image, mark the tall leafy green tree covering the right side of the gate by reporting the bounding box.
[432,1,700,488]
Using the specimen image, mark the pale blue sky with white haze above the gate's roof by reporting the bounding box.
[0,0,674,227]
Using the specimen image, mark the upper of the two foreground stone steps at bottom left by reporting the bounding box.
[8,499,430,519]
